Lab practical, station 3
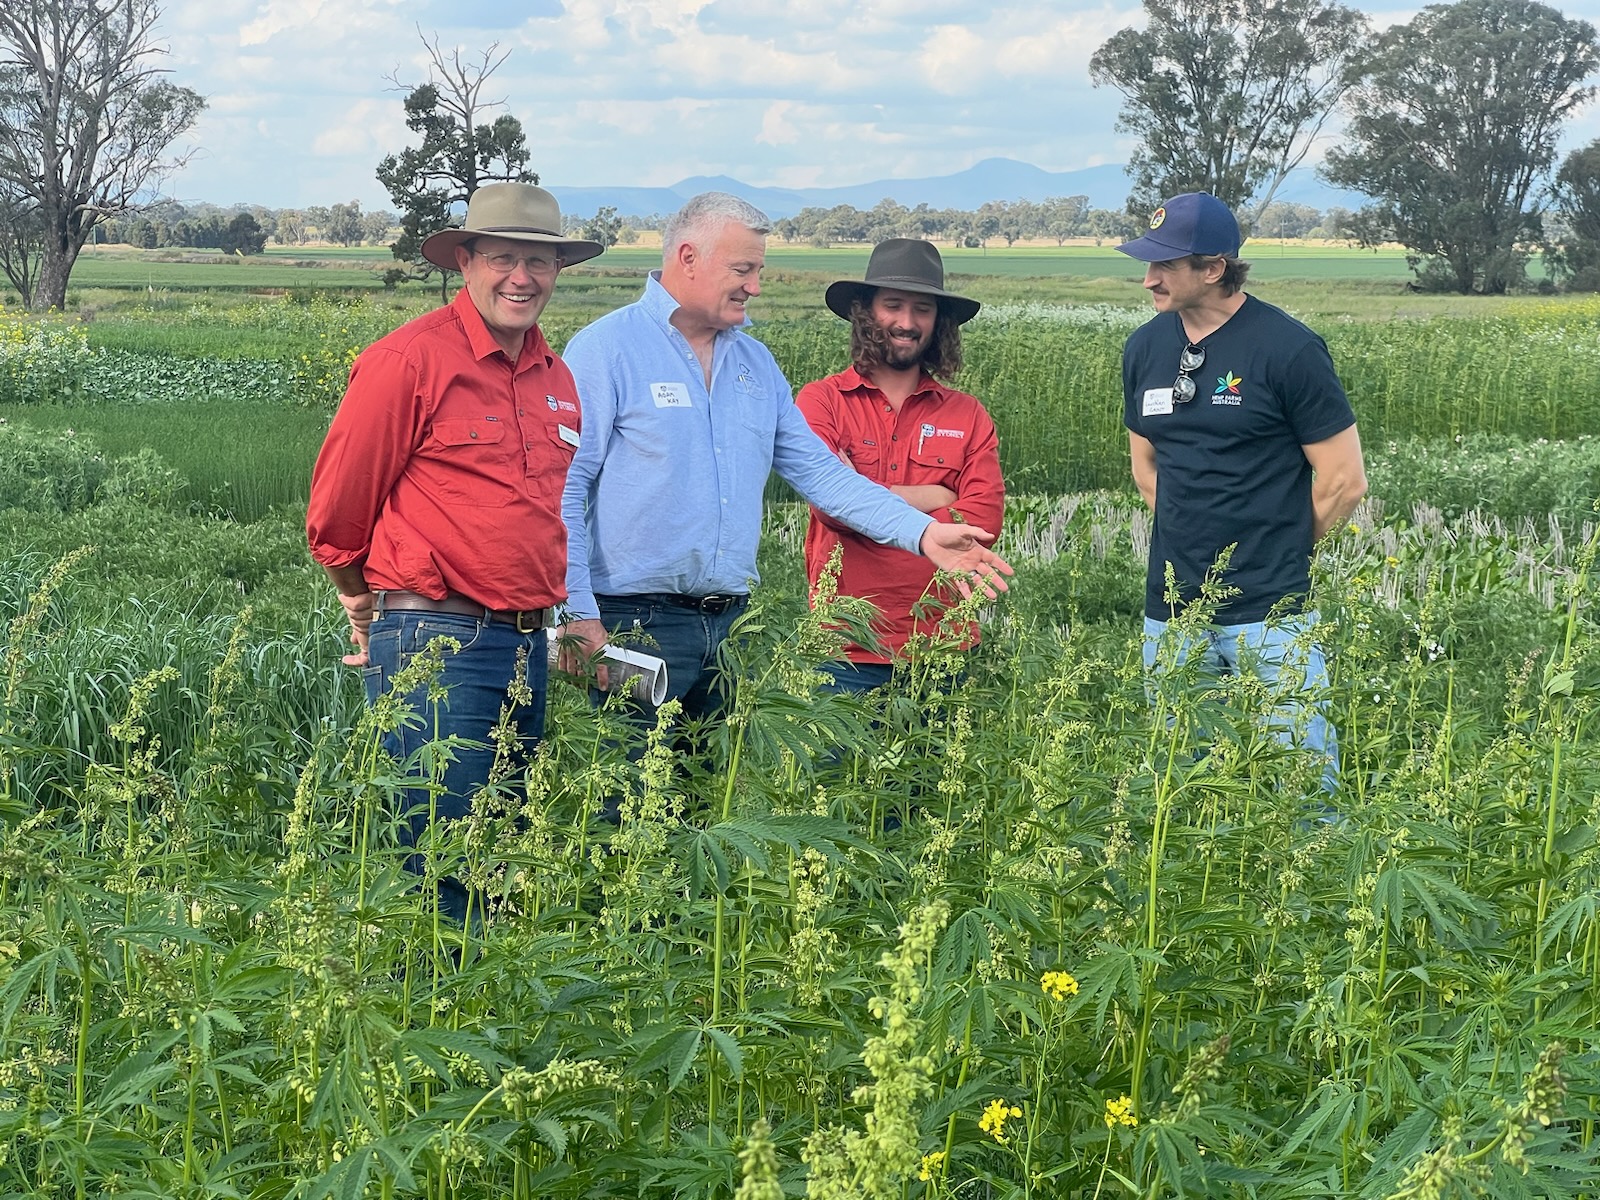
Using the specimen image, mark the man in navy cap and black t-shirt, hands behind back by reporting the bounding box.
[1117,192,1366,794]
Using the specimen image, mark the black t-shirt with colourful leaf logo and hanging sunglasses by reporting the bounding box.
[1122,296,1355,624]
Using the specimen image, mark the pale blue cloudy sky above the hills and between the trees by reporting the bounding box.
[157,0,1600,210]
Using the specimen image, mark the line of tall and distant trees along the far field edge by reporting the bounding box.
[0,0,1600,307]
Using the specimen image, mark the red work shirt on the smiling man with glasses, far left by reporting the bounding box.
[306,288,579,610]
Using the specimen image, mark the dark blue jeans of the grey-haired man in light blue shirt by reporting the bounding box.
[595,595,746,723]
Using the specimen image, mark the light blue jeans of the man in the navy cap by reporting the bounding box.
[1144,613,1339,795]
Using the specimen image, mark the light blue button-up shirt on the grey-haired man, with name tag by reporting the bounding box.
[562,272,931,618]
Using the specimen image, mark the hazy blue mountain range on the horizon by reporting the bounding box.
[549,158,1366,221]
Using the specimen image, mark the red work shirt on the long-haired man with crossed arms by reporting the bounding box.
[795,366,1005,662]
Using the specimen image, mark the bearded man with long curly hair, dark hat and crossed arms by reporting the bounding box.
[795,238,1005,691]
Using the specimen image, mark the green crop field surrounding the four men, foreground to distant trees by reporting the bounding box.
[0,262,1600,1200]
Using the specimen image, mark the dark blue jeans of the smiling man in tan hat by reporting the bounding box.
[362,613,549,922]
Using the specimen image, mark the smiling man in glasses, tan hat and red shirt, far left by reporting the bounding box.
[306,182,602,920]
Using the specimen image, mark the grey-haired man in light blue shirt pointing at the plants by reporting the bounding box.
[562,192,1011,717]
